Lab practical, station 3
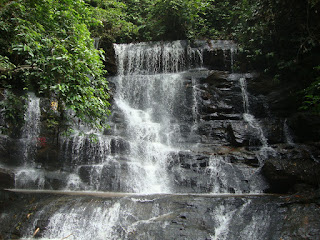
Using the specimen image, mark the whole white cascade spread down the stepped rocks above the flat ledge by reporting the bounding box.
[9,41,267,194]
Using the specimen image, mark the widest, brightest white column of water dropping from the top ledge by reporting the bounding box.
[115,41,205,192]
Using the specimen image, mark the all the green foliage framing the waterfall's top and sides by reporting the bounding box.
[0,0,320,131]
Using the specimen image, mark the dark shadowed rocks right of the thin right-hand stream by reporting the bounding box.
[242,75,320,193]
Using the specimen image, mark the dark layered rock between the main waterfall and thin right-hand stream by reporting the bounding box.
[192,71,268,147]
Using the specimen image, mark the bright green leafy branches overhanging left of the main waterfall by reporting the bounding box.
[0,0,113,130]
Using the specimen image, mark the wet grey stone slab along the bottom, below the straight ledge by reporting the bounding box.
[0,189,320,240]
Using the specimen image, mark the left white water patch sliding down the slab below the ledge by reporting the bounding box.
[39,202,121,240]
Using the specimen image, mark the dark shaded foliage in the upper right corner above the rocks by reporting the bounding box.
[234,0,320,112]
